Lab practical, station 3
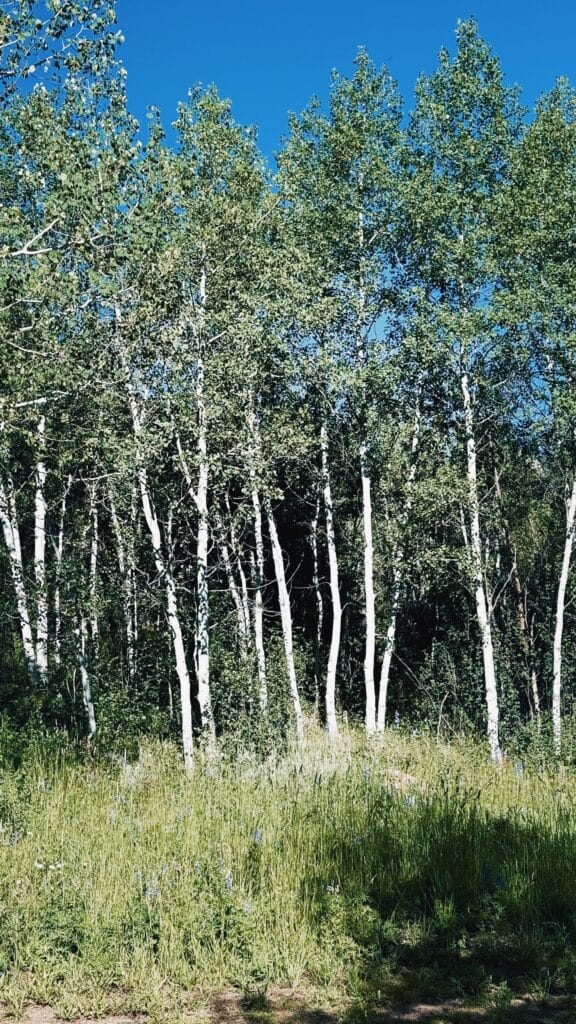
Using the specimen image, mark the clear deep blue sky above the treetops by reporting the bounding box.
[118,0,576,162]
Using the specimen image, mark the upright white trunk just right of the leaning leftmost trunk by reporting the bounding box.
[34,414,48,686]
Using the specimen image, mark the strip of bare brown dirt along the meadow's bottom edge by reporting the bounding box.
[0,989,576,1024]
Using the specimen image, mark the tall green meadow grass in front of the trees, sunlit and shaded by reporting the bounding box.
[0,731,576,1016]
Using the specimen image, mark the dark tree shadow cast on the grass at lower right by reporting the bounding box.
[276,788,576,1024]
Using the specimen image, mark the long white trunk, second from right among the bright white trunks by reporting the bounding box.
[460,370,502,764]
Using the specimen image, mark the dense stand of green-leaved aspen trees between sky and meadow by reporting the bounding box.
[0,0,576,757]
